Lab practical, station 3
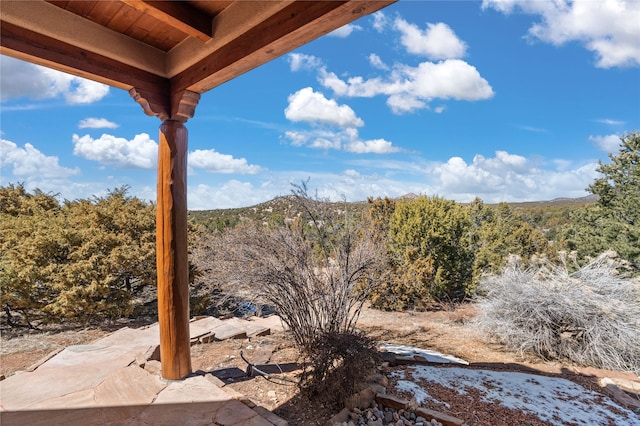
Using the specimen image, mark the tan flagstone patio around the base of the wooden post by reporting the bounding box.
[0,317,286,426]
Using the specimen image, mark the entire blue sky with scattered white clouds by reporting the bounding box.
[0,0,640,210]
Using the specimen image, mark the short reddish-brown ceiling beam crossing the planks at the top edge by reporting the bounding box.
[122,0,213,42]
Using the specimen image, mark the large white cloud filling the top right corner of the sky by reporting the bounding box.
[482,0,640,68]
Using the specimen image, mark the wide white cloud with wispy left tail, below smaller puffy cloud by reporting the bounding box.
[319,59,494,113]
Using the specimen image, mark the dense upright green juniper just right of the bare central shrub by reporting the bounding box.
[371,197,473,310]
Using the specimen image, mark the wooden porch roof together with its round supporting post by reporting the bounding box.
[0,0,396,380]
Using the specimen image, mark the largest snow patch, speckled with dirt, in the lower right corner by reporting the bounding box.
[398,365,640,426]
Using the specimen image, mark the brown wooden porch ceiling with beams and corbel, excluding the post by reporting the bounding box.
[0,0,396,120]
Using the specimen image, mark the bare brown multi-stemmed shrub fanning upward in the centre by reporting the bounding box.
[206,183,384,349]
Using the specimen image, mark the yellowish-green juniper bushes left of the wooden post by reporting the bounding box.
[0,185,156,327]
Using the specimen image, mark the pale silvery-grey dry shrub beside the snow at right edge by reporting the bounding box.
[476,253,640,373]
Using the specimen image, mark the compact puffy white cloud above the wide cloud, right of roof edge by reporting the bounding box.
[394,18,467,60]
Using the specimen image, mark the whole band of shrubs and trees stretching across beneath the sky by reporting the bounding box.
[0,132,640,378]
